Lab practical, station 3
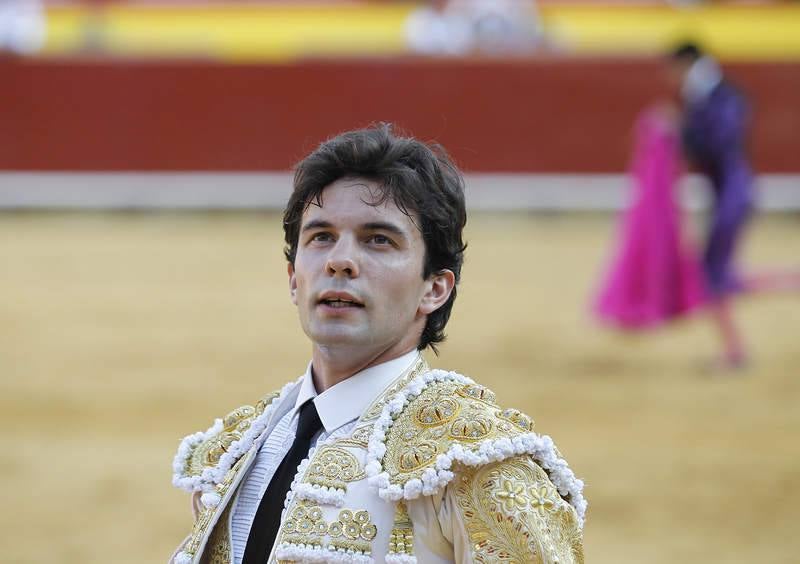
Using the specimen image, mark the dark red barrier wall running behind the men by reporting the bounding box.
[0,59,800,172]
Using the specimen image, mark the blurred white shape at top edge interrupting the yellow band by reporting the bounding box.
[406,0,541,55]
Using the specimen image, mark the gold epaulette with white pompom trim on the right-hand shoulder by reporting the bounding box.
[366,370,587,524]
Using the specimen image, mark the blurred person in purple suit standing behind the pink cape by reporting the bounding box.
[669,43,800,370]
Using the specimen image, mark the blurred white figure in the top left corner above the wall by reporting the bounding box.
[0,0,47,55]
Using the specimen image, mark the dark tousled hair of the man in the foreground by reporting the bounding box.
[283,123,467,352]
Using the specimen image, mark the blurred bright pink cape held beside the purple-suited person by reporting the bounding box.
[593,109,704,329]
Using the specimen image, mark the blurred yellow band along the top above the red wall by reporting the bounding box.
[40,4,800,61]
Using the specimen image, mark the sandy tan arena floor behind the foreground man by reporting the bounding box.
[0,214,800,564]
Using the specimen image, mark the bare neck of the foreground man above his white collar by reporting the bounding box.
[311,344,414,394]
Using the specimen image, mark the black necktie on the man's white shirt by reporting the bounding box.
[242,400,322,564]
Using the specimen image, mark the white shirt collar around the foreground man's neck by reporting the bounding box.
[295,350,420,434]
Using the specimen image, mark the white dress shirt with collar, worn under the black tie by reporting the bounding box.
[231,350,419,564]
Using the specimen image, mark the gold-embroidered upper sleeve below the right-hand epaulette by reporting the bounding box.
[455,455,583,564]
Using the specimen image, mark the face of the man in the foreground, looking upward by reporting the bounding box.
[289,178,438,352]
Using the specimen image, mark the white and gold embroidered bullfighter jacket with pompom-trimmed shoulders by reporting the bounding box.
[172,360,586,564]
